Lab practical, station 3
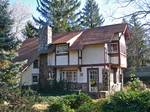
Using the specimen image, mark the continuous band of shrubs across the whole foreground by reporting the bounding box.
[0,80,150,112]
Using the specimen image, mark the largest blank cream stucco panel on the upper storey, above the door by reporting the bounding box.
[82,45,104,64]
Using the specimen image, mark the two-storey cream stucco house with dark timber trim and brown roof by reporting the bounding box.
[15,24,129,94]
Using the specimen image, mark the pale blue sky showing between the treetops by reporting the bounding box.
[10,0,135,25]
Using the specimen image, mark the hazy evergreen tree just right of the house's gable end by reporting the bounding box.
[127,15,150,67]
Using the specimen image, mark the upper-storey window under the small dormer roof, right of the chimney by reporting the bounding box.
[56,44,68,54]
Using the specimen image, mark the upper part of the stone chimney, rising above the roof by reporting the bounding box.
[39,25,52,53]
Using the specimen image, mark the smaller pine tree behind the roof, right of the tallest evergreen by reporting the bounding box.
[81,0,104,28]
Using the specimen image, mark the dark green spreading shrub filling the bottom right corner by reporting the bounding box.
[102,91,150,112]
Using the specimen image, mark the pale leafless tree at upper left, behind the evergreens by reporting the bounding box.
[10,2,32,40]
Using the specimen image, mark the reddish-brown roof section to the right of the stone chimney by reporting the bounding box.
[53,24,128,49]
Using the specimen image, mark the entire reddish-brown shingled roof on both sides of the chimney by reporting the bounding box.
[15,24,128,71]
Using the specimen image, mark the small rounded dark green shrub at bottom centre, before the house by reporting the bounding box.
[64,93,92,109]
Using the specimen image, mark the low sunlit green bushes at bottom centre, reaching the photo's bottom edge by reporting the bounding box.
[48,93,92,112]
